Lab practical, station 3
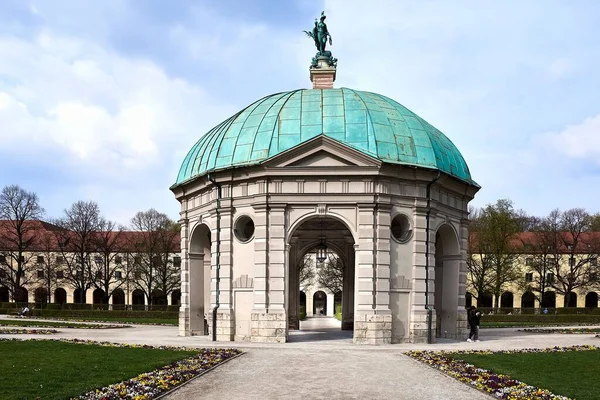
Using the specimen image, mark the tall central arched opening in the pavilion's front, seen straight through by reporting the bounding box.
[287,216,355,340]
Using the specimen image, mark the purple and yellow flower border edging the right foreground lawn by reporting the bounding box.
[406,345,598,400]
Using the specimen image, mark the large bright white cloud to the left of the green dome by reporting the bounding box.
[0,31,234,223]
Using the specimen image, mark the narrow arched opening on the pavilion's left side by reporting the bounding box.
[186,224,212,335]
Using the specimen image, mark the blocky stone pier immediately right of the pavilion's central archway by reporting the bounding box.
[354,205,392,344]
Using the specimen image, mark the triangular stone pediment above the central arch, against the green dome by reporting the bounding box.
[264,135,381,168]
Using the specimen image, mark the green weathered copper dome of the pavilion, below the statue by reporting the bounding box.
[174,88,475,186]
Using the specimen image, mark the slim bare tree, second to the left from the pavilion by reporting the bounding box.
[88,218,125,304]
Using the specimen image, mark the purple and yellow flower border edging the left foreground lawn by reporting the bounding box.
[0,338,242,400]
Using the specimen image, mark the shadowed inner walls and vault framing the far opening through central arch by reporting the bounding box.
[287,215,355,336]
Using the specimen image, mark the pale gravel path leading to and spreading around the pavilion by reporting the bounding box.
[0,316,600,400]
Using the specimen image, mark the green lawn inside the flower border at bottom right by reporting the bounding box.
[452,350,600,400]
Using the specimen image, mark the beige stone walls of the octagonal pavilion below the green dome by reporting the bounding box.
[173,135,477,344]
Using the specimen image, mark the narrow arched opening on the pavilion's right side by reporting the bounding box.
[433,224,464,337]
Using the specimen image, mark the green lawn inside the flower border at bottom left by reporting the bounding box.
[0,341,195,400]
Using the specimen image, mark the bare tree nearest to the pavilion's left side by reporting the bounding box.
[131,208,179,305]
